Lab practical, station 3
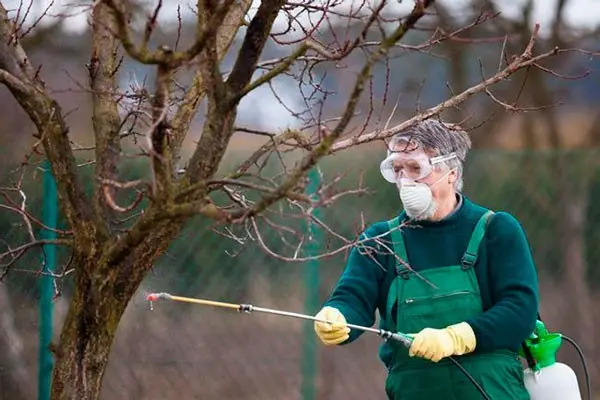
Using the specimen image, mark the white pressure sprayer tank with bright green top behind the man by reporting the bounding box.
[522,321,581,400]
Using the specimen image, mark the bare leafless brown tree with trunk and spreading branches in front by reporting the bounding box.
[0,0,592,399]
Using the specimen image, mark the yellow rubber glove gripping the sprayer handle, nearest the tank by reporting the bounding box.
[408,322,477,362]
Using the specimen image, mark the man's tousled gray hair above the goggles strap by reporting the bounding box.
[390,119,471,192]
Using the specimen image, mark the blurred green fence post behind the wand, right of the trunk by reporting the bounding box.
[302,167,321,400]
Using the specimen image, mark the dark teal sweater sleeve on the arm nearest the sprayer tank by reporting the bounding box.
[467,212,539,351]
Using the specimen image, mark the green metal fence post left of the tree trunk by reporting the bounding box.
[38,161,58,400]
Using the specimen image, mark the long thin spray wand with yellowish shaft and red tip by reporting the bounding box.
[146,293,412,348]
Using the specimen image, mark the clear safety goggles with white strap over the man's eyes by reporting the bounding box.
[379,150,456,183]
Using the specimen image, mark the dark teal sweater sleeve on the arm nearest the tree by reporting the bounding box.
[325,225,385,344]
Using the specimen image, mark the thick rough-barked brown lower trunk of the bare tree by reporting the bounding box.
[51,220,183,400]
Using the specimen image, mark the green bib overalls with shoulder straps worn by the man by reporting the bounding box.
[382,211,529,400]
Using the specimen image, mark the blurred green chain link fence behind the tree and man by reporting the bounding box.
[0,150,600,400]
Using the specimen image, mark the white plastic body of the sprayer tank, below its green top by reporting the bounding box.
[524,362,581,400]
